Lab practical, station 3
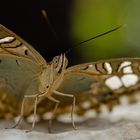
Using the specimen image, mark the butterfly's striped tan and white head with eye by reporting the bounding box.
[51,54,68,73]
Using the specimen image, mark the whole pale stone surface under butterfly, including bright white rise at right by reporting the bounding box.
[0,104,140,140]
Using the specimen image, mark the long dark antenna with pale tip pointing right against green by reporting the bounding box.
[65,24,126,54]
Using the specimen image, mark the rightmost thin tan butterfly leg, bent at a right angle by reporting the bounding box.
[53,90,76,130]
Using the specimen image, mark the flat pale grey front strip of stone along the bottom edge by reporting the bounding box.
[0,123,140,140]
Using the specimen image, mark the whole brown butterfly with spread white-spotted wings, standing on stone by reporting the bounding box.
[0,25,140,130]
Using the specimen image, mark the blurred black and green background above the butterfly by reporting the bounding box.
[0,0,140,65]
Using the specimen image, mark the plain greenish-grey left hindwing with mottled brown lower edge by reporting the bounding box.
[0,54,41,118]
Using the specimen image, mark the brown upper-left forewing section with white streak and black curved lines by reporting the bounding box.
[0,25,46,65]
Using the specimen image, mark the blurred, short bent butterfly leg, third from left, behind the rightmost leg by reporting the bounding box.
[47,96,60,133]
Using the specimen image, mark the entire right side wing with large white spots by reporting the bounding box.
[49,58,140,113]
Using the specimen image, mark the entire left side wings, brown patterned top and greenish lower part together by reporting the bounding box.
[0,25,46,118]
